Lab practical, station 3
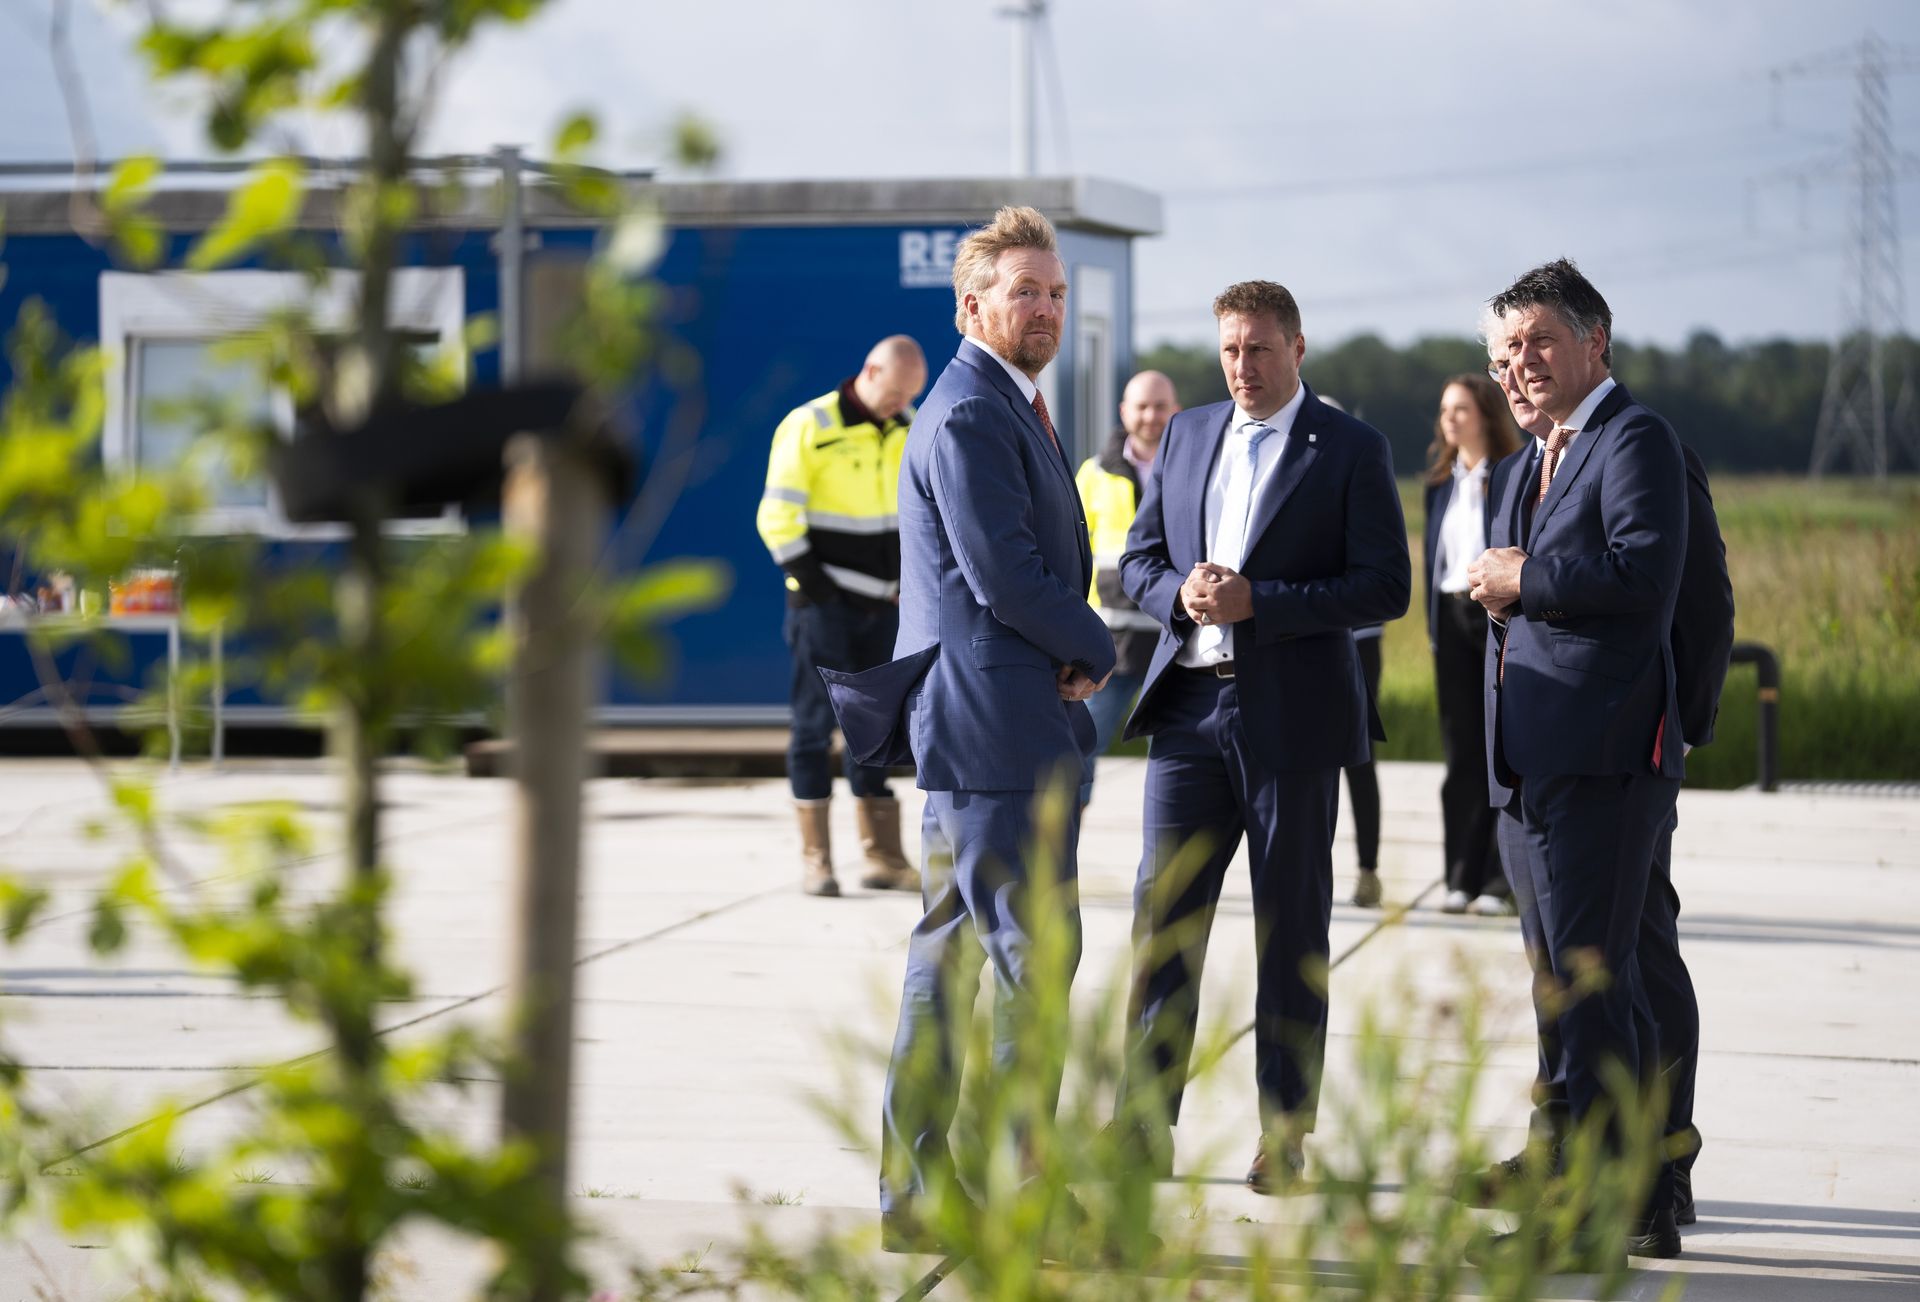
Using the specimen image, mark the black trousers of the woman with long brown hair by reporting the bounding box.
[1434,591,1509,897]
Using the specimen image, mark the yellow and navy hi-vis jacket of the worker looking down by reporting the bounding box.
[755,390,914,601]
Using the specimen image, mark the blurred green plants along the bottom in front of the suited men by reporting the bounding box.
[607,784,1674,1302]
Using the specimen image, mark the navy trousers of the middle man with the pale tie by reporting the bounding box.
[1116,666,1340,1131]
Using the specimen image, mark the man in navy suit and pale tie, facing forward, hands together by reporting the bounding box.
[1116,280,1411,1193]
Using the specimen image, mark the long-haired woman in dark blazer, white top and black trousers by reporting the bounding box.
[1423,374,1521,914]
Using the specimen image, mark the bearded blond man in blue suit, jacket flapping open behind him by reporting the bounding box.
[828,207,1114,1250]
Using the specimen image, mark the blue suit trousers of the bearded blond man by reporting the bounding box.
[879,791,1081,1212]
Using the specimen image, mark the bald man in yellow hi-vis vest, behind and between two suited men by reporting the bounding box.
[1073,371,1181,807]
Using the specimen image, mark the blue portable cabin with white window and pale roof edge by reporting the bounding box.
[0,159,1162,726]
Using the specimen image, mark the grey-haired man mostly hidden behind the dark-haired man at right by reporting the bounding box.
[1461,297,1734,1225]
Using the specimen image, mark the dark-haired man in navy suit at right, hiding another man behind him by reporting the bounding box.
[1469,259,1688,1267]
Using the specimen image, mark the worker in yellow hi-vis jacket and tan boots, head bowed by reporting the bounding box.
[756,334,927,895]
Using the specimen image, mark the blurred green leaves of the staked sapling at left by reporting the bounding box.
[0,0,728,1302]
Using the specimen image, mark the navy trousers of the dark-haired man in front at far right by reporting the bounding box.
[1500,774,1680,1208]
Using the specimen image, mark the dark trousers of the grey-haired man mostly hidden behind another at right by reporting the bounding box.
[1515,814,1701,1171]
